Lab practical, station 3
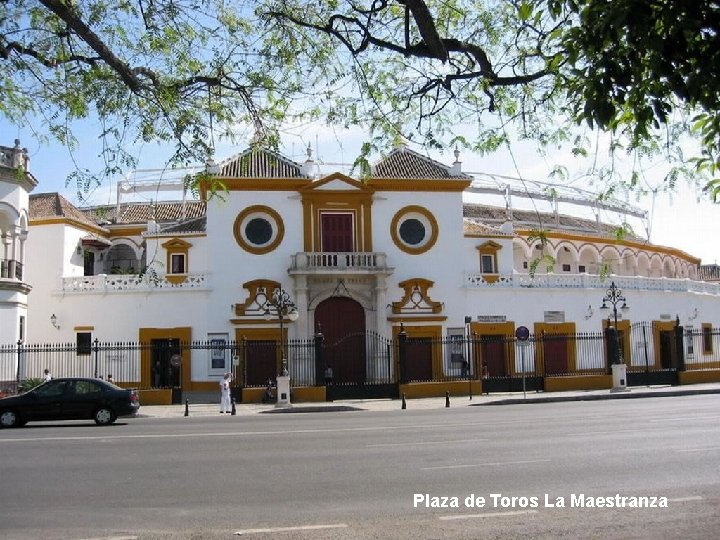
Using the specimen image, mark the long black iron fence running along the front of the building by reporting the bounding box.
[0,323,720,392]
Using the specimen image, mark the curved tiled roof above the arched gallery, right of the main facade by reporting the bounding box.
[463,204,643,240]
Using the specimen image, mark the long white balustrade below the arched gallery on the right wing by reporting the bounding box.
[464,273,720,295]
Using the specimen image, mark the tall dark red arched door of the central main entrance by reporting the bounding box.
[315,296,366,385]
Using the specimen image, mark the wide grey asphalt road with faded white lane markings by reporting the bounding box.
[0,395,720,539]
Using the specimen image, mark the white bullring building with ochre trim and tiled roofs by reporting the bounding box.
[0,141,720,398]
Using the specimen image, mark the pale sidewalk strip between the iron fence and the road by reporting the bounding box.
[138,383,720,418]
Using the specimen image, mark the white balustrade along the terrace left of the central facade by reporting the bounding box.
[60,274,209,293]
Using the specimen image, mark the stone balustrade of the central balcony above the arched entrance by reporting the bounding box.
[290,252,393,274]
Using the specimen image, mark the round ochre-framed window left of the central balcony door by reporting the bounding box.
[233,206,285,255]
